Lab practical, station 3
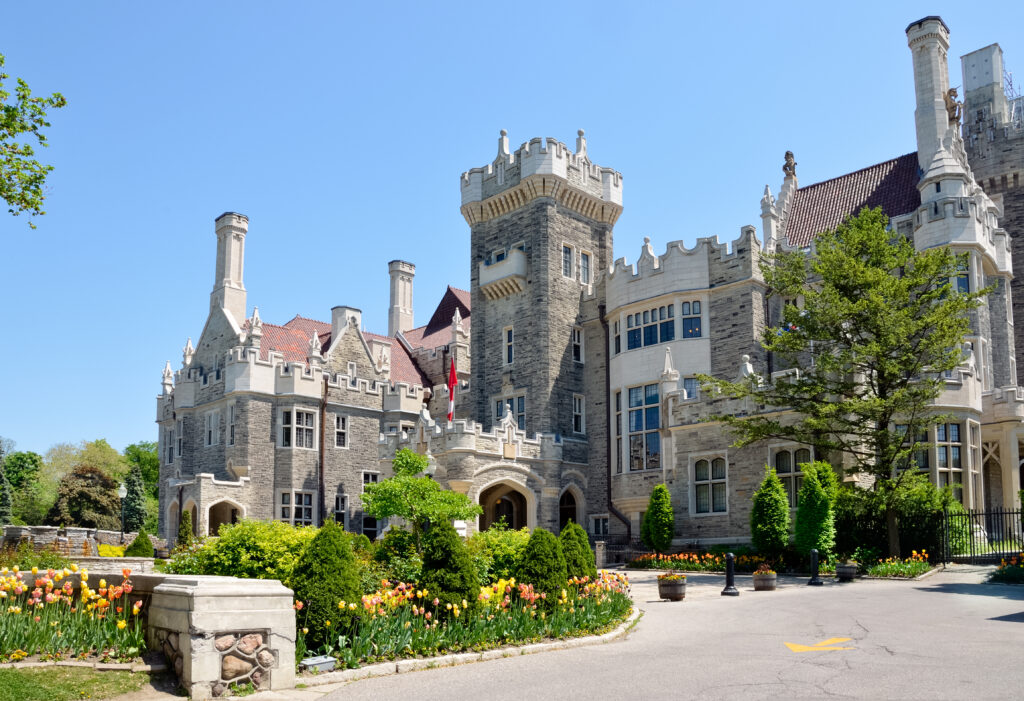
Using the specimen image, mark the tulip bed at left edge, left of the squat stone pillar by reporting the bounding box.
[0,565,145,662]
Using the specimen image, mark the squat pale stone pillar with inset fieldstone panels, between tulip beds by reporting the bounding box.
[146,575,295,699]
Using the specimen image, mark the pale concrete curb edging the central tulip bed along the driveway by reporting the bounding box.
[295,604,641,687]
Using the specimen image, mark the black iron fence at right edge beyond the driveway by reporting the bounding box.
[942,509,1024,565]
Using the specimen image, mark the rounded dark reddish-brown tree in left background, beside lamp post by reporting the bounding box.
[46,465,121,530]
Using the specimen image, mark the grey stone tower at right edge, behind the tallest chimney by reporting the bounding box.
[961,44,1024,384]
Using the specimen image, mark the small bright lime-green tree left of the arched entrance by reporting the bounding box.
[362,448,483,550]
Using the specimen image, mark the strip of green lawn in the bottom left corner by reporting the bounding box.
[0,667,150,701]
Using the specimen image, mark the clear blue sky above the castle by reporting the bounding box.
[0,2,1024,452]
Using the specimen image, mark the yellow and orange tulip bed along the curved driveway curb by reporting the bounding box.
[296,572,632,667]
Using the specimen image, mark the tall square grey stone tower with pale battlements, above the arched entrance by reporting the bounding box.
[461,130,623,448]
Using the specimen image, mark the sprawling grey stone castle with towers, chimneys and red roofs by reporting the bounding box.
[157,16,1024,543]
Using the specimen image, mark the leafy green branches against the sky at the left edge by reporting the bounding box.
[0,53,67,228]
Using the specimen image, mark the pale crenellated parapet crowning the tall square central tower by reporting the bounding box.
[460,129,623,225]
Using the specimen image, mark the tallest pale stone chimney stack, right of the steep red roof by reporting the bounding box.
[906,15,949,171]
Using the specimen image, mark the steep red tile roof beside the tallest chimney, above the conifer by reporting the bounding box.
[785,152,921,248]
